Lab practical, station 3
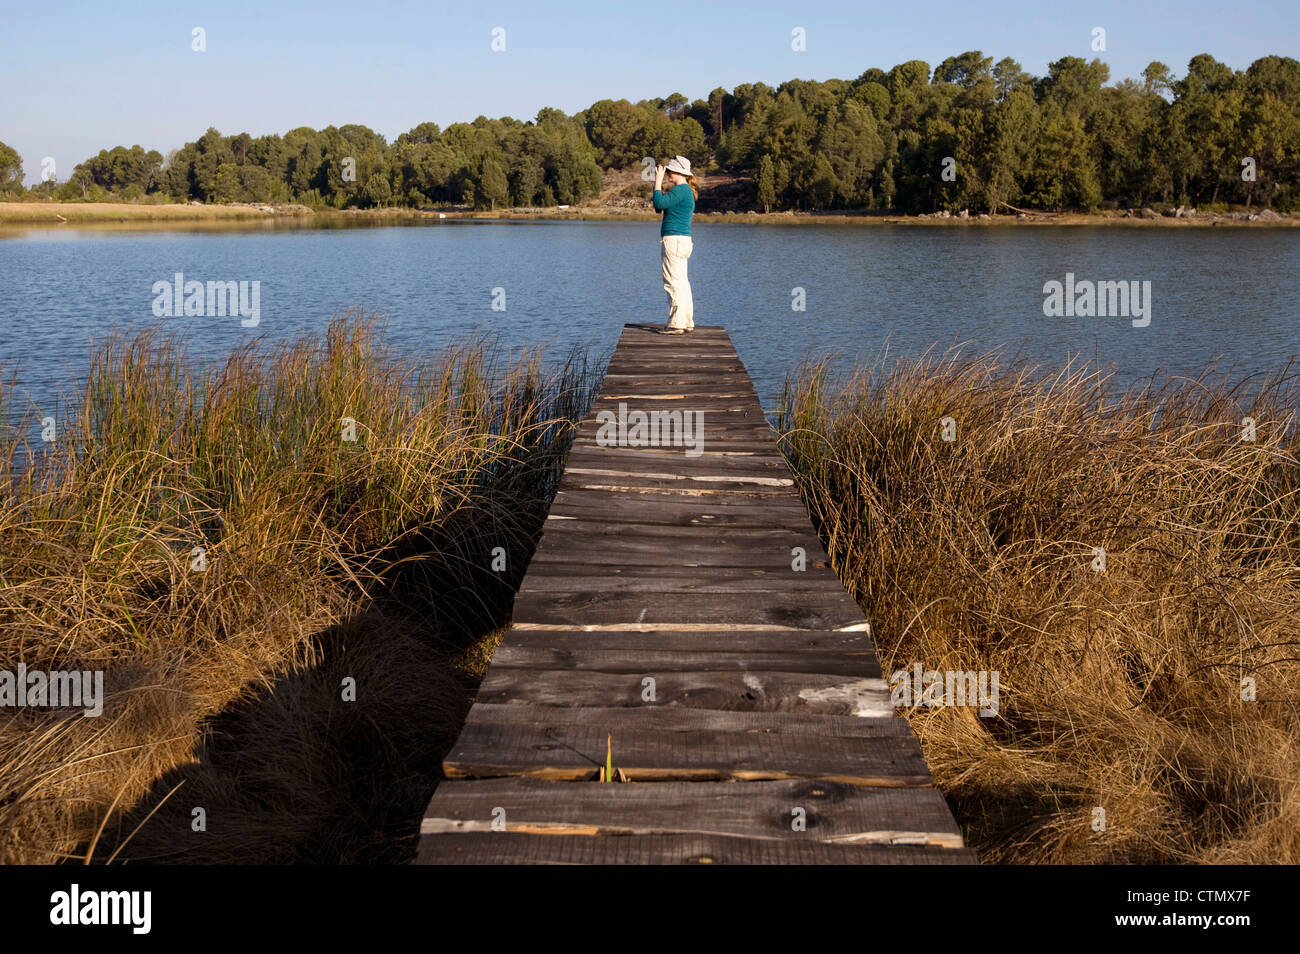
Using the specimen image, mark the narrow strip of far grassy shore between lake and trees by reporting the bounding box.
[0,201,1300,229]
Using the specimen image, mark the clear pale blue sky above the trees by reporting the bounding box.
[0,0,1300,182]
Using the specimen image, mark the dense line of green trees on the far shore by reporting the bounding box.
[0,51,1300,213]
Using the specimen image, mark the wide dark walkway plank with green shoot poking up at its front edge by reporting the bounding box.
[442,721,931,788]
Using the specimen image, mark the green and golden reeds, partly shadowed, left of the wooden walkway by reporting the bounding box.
[0,312,593,863]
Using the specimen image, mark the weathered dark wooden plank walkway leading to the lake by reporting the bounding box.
[416,325,975,864]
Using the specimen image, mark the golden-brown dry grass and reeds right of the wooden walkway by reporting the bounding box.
[779,352,1300,864]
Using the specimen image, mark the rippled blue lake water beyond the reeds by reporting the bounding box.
[0,221,1300,408]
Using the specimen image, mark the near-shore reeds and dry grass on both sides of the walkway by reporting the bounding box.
[0,313,1300,863]
